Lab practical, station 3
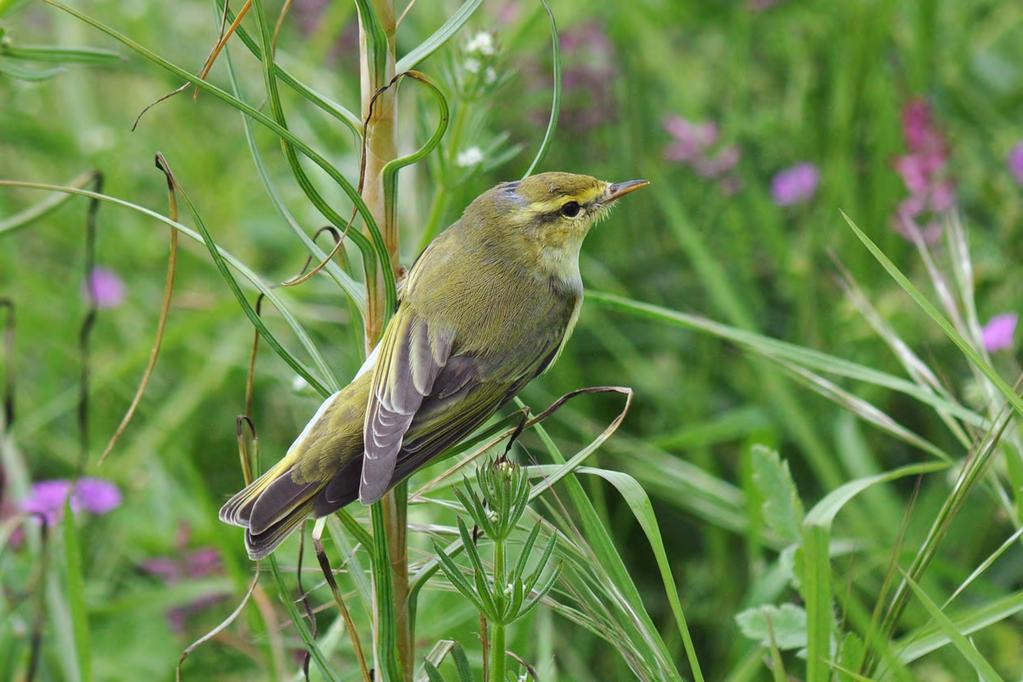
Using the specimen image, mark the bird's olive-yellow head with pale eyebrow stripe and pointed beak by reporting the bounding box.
[466,173,650,278]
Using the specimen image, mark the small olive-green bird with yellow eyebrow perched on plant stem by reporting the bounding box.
[220,173,649,559]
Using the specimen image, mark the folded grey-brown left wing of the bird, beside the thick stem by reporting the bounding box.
[359,306,454,504]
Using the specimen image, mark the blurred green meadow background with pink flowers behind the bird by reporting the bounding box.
[0,0,1023,680]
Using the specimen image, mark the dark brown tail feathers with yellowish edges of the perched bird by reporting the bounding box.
[220,460,326,559]
